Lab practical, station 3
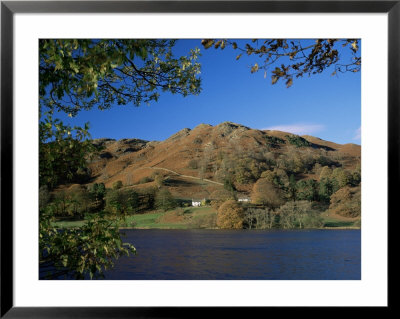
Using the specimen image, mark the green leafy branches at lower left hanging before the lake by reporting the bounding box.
[39,211,136,279]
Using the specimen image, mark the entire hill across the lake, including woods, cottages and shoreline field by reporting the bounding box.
[40,122,361,229]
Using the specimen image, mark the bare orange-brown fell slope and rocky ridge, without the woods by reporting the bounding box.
[89,122,361,198]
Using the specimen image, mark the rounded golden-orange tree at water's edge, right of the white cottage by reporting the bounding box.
[217,199,245,229]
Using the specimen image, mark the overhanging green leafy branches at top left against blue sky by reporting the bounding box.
[39,39,201,116]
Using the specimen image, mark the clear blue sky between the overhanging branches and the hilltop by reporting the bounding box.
[51,40,361,144]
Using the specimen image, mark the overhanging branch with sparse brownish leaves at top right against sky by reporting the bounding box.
[201,39,361,87]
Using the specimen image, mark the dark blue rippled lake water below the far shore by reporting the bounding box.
[99,229,361,280]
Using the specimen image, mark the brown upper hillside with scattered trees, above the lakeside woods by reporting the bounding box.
[83,122,361,198]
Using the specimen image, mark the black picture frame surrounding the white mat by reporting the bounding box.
[0,0,394,318]
